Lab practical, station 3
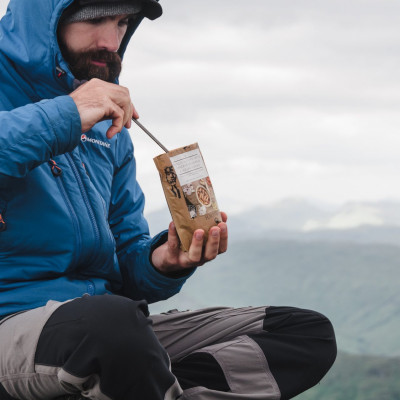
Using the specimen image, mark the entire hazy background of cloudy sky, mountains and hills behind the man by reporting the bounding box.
[0,0,400,400]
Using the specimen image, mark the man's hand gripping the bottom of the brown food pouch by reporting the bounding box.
[151,212,228,275]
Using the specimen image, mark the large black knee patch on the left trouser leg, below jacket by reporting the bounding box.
[35,295,175,399]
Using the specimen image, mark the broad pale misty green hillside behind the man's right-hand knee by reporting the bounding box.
[151,240,400,354]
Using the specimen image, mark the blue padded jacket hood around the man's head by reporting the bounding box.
[0,0,158,101]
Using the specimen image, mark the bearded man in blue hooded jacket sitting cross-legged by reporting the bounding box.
[0,0,336,400]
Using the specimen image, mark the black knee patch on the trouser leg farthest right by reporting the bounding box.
[249,307,337,400]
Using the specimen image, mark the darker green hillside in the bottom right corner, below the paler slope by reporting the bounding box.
[296,353,400,400]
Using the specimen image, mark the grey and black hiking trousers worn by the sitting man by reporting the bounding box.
[0,295,336,400]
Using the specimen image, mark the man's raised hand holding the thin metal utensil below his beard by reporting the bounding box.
[70,78,139,139]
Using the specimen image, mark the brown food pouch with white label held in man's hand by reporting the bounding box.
[154,143,222,251]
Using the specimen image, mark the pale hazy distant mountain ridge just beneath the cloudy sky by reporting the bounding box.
[147,199,400,245]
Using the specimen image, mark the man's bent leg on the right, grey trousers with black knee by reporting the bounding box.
[152,307,336,400]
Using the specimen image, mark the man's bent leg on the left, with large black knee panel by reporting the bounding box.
[0,295,181,400]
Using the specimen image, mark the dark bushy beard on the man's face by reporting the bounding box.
[62,46,122,83]
